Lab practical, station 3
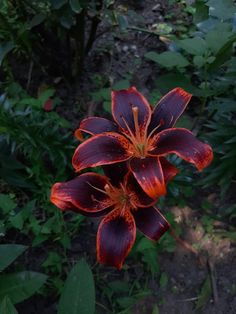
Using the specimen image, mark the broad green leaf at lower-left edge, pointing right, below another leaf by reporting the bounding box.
[0,271,47,304]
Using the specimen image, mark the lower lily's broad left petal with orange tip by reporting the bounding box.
[50,172,112,214]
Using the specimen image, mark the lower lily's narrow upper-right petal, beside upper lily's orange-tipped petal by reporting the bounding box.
[125,172,157,207]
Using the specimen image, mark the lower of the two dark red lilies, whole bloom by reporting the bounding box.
[51,172,172,269]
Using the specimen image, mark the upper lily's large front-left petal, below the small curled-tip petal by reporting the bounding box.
[72,132,130,171]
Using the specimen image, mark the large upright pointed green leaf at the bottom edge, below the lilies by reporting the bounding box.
[58,259,95,314]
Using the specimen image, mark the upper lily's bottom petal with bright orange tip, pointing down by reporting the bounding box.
[130,157,166,198]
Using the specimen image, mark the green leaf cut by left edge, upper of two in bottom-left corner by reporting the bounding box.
[0,244,27,271]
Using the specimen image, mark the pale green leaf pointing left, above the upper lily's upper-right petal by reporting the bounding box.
[145,51,189,68]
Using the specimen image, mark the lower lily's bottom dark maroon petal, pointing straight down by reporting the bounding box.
[97,209,136,269]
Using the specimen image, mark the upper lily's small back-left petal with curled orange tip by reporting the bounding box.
[75,117,118,140]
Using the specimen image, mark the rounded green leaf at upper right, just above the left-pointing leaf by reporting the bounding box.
[178,37,207,56]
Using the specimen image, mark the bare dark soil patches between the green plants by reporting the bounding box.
[5,0,236,314]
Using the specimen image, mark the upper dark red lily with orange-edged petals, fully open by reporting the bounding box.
[72,87,213,198]
